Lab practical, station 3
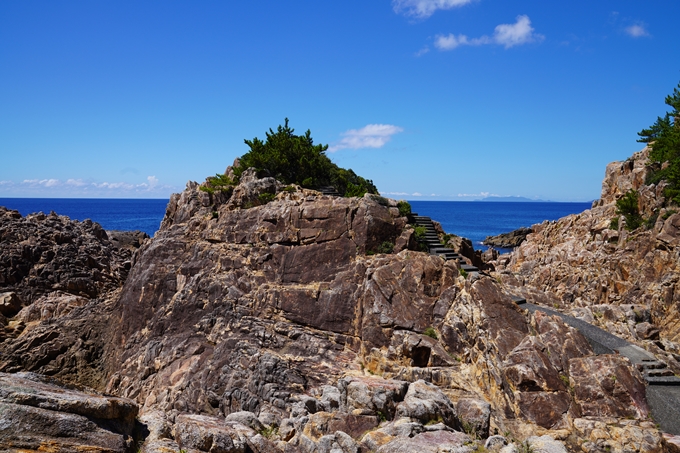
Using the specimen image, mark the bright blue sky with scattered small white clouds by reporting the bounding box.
[0,0,680,201]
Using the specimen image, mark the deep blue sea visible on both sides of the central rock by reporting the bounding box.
[0,198,590,245]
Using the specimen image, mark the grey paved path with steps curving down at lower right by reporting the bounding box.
[512,297,680,435]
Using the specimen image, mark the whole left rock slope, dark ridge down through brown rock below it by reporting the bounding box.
[0,207,137,387]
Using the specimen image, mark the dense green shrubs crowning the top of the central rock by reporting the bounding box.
[234,118,378,197]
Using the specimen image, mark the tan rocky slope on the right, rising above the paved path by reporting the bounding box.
[497,149,680,373]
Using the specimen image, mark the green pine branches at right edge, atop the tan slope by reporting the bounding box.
[638,80,680,203]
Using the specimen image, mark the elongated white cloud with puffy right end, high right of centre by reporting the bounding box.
[434,15,545,50]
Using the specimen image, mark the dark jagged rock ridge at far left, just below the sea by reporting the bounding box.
[0,207,131,308]
